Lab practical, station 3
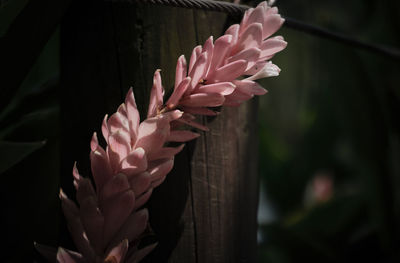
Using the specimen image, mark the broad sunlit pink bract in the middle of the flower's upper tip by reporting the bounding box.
[234,23,263,53]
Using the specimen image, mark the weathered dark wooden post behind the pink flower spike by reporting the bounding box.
[60,1,258,262]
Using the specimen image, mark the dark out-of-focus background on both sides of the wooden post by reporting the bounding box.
[0,0,400,263]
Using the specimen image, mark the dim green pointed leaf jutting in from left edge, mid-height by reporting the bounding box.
[0,141,46,174]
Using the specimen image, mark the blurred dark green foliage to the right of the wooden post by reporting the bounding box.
[259,0,400,263]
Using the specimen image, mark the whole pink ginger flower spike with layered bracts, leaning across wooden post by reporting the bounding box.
[37,2,286,262]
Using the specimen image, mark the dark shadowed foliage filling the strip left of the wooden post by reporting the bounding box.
[0,0,59,262]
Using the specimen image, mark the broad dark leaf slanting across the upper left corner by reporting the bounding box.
[0,0,71,112]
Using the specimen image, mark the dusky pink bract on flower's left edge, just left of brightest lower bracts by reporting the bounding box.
[90,147,112,191]
